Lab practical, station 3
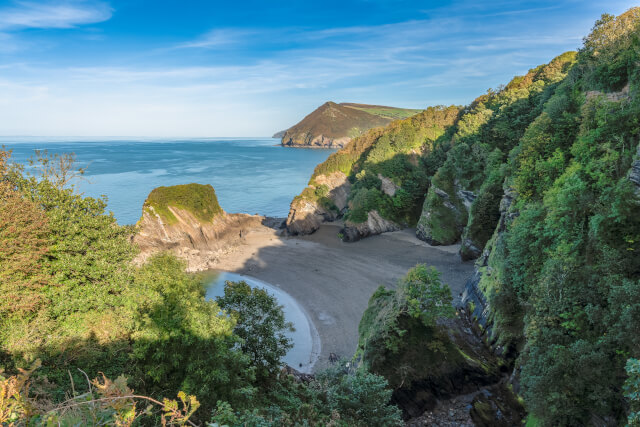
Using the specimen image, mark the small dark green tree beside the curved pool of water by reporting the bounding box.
[216,282,293,381]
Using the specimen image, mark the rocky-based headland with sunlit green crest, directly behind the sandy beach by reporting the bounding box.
[287,106,459,237]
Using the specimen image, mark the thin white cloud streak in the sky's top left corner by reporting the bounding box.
[0,1,113,31]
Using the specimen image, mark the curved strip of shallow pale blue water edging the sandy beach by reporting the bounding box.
[205,271,320,373]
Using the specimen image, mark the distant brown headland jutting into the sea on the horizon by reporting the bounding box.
[276,102,419,148]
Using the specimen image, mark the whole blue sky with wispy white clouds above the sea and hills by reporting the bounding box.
[0,0,634,137]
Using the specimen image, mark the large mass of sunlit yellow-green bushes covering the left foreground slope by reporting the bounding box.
[0,151,255,422]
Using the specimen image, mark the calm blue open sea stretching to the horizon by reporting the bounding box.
[0,137,334,224]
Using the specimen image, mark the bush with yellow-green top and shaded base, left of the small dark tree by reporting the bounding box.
[131,255,255,413]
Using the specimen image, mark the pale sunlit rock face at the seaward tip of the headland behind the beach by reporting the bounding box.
[286,172,351,235]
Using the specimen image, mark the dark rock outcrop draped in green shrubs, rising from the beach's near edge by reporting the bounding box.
[355,265,499,417]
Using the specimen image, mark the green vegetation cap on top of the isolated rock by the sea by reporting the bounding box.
[144,184,223,224]
